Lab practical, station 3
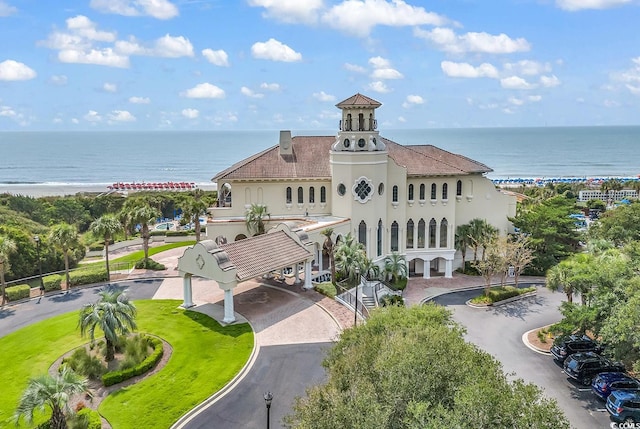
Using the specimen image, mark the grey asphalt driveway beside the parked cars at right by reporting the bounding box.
[433,287,610,429]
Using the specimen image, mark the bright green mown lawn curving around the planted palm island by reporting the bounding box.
[0,300,253,429]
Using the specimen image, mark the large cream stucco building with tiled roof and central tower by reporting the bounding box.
[207,94,516,277]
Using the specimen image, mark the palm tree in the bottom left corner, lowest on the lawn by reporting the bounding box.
[14,365,87,429]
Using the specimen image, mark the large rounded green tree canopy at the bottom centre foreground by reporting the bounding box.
[285,305,569,429]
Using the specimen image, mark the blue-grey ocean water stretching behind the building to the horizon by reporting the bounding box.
[0,126,640,185]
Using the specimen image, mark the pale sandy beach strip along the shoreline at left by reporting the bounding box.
[0,183,216,198]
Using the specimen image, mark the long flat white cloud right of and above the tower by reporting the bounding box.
[413,28,531,54]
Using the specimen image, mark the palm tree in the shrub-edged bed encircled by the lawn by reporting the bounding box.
[79,288,136,362]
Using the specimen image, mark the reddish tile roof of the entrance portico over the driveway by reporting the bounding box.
[220,231,311,281]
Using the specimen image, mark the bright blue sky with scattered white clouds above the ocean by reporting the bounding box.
[0,0,640,131]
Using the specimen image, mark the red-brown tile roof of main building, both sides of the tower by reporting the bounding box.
[211,136,493,182]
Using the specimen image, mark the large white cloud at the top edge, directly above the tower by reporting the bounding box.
[322,0,448,37]
